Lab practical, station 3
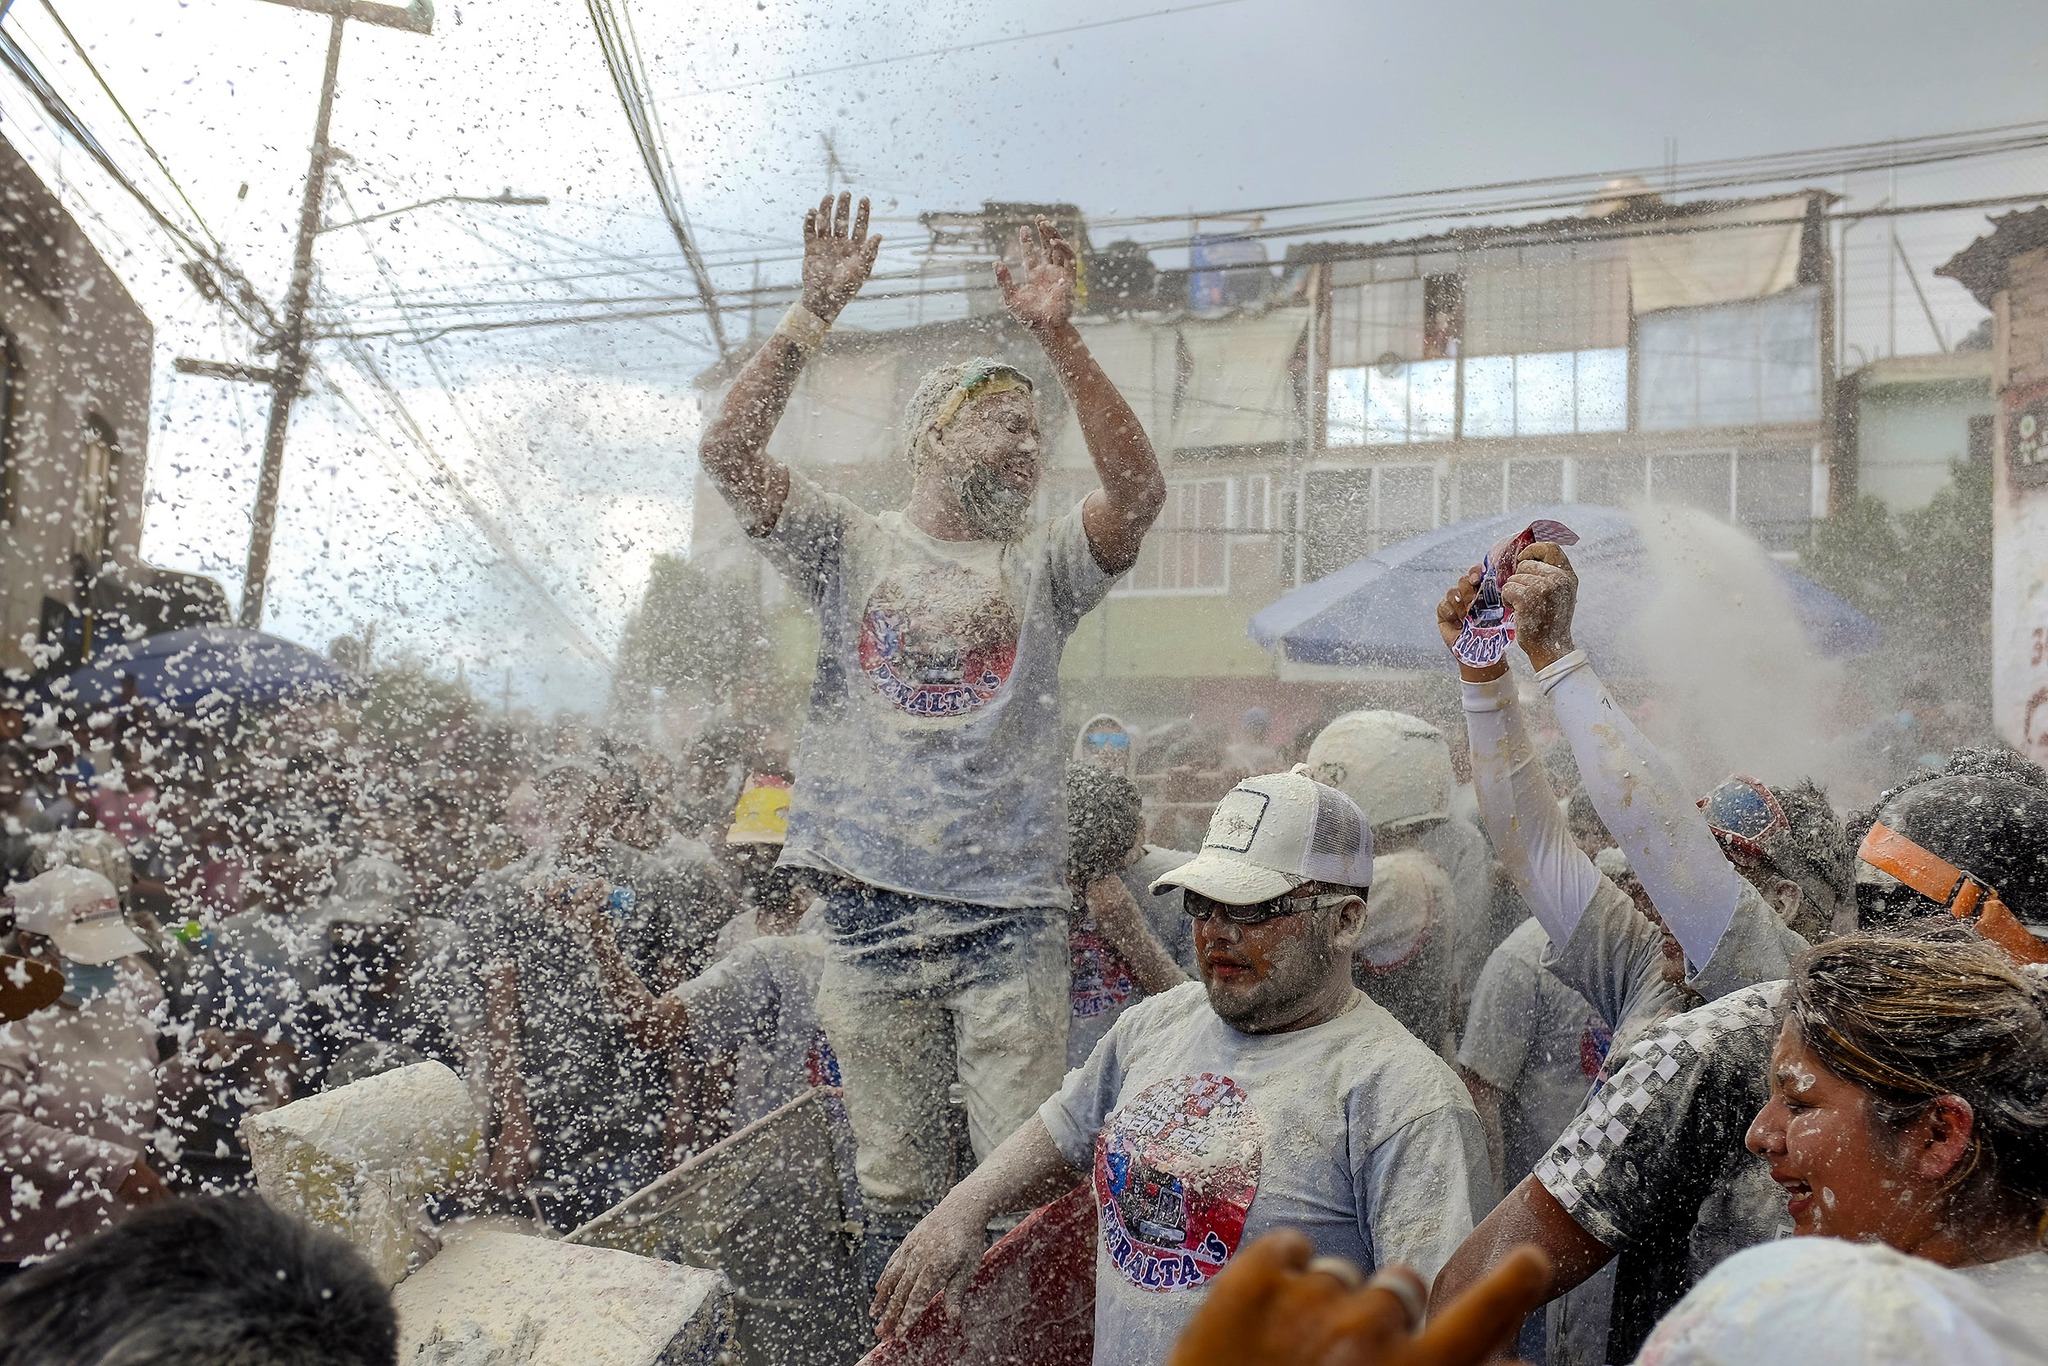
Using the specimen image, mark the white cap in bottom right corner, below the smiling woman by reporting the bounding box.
[1636,1237,2048,1366]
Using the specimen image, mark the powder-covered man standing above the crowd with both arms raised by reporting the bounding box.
[698,195,1165,1278]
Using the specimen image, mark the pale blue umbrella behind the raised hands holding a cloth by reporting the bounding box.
[1251,504,1882,674]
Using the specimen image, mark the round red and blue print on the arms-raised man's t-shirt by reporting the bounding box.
[860,563,1018,717]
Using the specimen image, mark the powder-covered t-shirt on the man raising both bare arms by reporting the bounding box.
[762,473,1112,917]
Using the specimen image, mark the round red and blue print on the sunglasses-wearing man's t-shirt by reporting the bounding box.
[1096,1073,1262,1292]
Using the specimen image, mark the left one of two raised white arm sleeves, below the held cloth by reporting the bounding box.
[1464,676,1599,948]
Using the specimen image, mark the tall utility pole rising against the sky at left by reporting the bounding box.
[240,0,434,631]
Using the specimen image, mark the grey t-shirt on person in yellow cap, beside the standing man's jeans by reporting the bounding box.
[670,934,836,1130]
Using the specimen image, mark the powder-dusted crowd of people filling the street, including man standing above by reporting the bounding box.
[0,195,2048,1366]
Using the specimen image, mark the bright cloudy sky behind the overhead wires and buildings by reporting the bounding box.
[0,0,2048,709]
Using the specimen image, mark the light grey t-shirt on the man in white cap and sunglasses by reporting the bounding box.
[1038,983,1489,1366]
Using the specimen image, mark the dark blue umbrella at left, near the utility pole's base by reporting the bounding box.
[47,627,362,713]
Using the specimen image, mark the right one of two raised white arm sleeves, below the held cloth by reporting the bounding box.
[1536,651,1741,973]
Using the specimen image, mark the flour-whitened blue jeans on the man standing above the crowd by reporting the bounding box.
[817,883,1069,1239]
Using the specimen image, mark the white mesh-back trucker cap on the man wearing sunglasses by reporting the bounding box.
[1151,764,1372,905]
